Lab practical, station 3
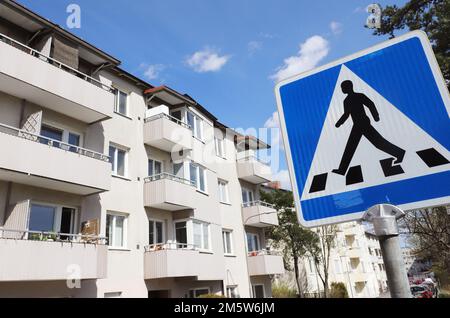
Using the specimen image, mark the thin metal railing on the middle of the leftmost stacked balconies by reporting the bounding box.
[0,124,110,162]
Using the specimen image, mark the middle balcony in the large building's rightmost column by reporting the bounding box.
[242,201,278,227]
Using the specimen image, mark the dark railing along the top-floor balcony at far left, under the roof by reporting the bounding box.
[0,33,114,93]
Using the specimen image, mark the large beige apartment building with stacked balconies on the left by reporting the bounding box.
[0,0,284,298]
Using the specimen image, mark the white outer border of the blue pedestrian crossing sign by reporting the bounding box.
[275,30,450,227]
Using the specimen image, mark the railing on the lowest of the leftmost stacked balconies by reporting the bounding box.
[0,228,107,245]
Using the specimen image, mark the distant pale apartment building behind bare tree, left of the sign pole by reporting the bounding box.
[304,222,387,298]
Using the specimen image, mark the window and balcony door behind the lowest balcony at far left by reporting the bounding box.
[28,204,77,239]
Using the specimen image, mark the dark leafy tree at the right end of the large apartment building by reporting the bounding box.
[261,190,319,296]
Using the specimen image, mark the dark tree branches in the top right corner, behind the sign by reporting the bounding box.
[374,0,450,88]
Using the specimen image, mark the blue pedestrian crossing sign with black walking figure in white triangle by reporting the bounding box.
[275,31,450,227]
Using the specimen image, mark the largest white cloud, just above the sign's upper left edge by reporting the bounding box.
[271,35,330,82]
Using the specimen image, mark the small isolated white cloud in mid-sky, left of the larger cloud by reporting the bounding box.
[186,48,231,73]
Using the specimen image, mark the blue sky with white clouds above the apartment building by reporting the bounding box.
[19,0,406,189]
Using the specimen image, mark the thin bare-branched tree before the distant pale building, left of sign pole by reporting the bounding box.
[305,225,338,298]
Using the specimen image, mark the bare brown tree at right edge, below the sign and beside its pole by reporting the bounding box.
[400,207,450,283]
